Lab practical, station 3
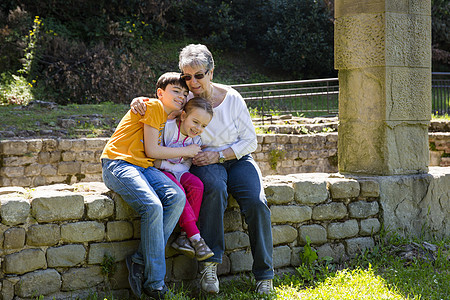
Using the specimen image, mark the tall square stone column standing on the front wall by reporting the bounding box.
[335,0,431,175]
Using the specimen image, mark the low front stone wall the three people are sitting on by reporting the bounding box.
[0,168,450,300]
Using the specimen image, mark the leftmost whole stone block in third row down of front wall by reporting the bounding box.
[4,249,47,275]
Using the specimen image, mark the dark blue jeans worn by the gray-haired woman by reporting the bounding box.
[190,155,273,280]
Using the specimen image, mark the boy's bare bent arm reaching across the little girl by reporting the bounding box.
[144,124,200,159]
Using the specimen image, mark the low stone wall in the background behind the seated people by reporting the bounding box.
[0,132,450,187]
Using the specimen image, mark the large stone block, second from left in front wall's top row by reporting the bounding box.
[31,191,84,223]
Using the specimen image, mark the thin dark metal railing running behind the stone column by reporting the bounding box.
[232,72,450,120]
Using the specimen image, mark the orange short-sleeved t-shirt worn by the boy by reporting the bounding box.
[101,99,167,168]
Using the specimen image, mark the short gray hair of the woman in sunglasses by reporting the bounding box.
[178,44,214,72]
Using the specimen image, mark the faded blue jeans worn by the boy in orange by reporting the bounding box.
[102,159,186,290]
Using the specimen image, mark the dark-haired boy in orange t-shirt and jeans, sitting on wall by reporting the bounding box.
[101,73,200,299]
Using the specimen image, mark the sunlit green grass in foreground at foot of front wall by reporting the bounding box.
[82,233,450,300]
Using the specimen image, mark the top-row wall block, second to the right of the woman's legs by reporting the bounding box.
[293,179,328,204]
